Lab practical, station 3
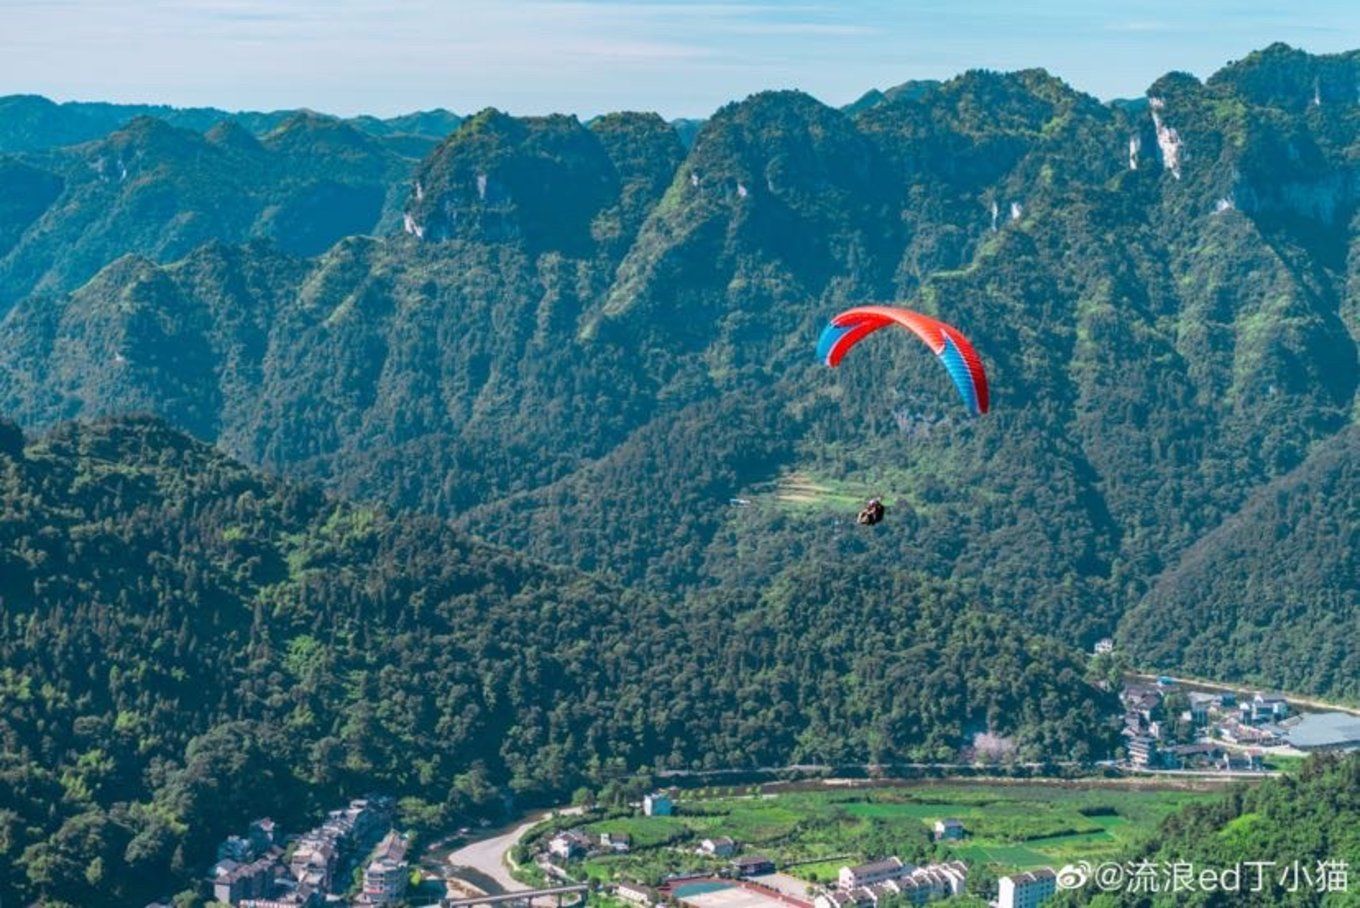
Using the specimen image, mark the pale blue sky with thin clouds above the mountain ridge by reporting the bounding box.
[0,0,1360,117]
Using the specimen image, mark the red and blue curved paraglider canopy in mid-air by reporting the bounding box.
[817,306,989,416]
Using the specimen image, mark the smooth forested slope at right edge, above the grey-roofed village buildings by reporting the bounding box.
[1121,427,1360,700]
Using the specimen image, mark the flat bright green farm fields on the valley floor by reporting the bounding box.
[573,783,1216,882]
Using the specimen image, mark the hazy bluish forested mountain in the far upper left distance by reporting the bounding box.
[0,114,418,309]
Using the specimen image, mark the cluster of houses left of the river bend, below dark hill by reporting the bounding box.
[208,797,399,908]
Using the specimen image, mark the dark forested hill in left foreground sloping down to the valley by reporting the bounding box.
[0,419,1112,905]
